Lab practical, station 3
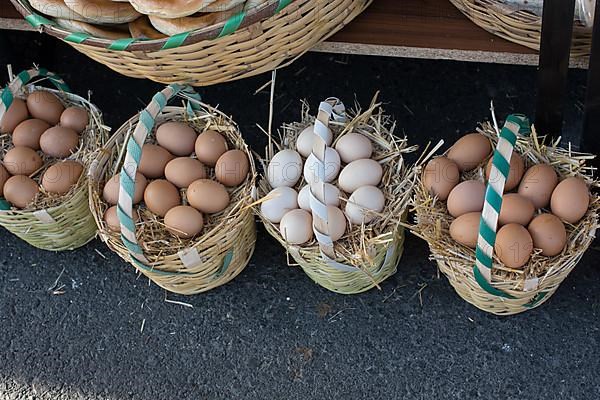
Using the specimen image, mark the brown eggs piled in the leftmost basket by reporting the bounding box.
[0,90,89,209]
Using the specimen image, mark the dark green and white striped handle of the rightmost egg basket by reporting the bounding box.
[473,114,530,299]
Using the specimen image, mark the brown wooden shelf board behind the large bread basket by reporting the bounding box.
[0,0,585,67]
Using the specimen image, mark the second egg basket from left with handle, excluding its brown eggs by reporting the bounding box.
[89,85,256,295]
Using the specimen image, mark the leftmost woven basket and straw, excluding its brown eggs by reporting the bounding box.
[0,69,109,251]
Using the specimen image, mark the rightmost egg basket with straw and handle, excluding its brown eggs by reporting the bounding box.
[413,116,600,315]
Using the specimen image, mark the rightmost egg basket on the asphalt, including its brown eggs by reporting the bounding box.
[413,115,600,315]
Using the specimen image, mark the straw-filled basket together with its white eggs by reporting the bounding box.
[257,94,415,294]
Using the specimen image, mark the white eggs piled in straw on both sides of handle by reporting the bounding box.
[261,125,385,245]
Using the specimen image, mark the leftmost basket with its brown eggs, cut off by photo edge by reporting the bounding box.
[0,68,108,251]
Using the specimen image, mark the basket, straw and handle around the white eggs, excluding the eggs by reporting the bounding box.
[256,94,416,294]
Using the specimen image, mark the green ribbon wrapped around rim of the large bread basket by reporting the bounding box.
[19,0,295,51]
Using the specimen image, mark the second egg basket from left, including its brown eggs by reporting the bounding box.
[89,85,256,295]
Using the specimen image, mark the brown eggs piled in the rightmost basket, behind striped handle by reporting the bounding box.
[423,133,590,269]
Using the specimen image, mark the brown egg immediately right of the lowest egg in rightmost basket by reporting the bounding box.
[527,214,567,257]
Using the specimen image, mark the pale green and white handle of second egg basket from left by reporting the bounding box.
[117,84,201,269]
